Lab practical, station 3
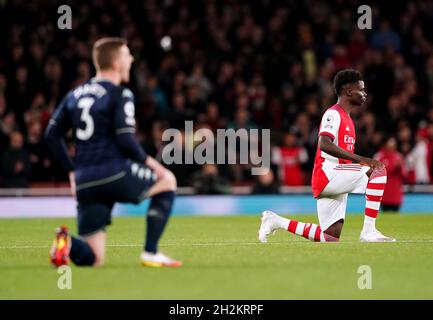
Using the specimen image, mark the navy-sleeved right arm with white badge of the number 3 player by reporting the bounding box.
[114,89,147,163]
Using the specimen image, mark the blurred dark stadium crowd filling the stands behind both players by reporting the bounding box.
[0,0,433,193]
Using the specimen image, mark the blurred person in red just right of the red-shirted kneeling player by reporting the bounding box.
[374,137,406,212]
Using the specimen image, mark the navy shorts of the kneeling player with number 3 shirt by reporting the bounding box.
[77,163,156,236]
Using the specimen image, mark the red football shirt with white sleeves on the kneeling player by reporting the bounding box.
[312,104,359,198]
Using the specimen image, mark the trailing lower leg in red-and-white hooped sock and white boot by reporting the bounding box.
[259,211,338,242]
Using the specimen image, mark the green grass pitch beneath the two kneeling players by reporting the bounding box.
[0,214,433,300]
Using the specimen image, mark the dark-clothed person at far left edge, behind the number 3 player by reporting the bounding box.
[1,131,31,188]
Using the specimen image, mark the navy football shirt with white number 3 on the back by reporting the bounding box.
[53,79,135,183]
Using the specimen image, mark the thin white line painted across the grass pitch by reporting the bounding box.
[0,239,433,250]
